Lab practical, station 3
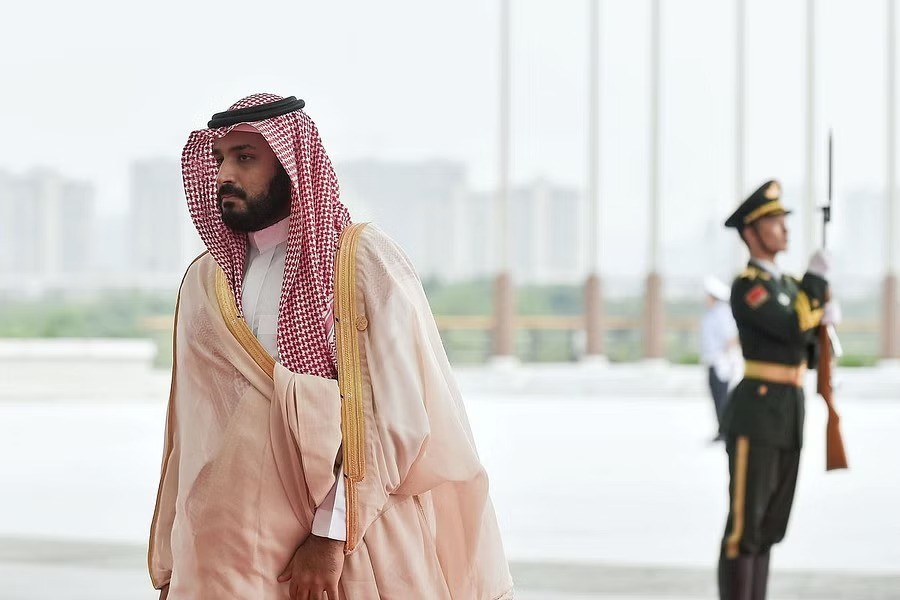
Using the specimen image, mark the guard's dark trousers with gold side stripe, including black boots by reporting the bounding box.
[719,436,800,600]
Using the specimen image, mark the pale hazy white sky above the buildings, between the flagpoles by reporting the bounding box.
[0,0,886,274]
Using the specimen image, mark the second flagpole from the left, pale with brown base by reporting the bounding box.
[584,0,603,359]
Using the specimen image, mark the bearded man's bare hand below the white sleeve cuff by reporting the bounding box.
[278,535,344,600]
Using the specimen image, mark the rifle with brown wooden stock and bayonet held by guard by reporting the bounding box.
[816,131,847,471]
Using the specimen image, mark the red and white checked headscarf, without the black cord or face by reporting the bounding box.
[181,94,350,378]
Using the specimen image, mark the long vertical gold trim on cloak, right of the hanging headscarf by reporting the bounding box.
[334,223,368,552]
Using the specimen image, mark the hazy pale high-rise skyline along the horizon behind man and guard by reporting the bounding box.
[0,157,884,296]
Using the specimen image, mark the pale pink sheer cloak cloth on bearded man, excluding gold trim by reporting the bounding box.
[149,226,512,600]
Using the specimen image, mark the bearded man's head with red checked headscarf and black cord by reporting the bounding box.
[181,94,350,377]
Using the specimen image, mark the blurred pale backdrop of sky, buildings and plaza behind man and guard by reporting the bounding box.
[0,0,900,600]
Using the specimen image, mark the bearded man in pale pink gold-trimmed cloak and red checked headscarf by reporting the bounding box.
[149,94,512,600]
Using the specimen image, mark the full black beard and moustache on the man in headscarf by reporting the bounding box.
[216,164,291,232]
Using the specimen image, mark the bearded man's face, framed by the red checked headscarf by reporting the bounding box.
[213,130,291,231]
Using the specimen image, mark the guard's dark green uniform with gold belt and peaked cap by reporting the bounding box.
[719,181,828,600]
